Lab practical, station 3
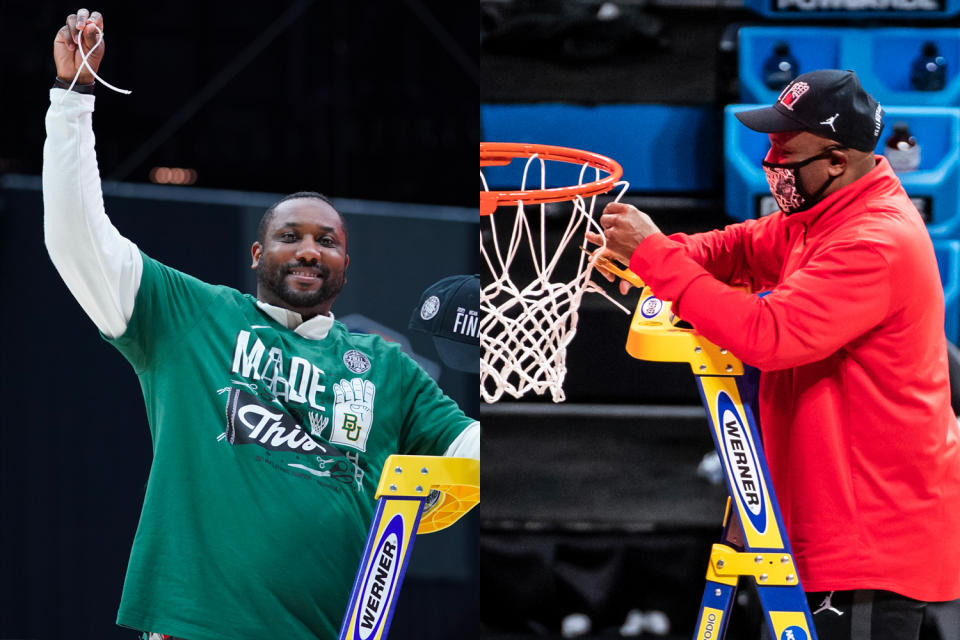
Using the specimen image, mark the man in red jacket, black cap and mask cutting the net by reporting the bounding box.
[588,70,960,640]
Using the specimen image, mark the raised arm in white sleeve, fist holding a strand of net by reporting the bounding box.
[43,9,143,337]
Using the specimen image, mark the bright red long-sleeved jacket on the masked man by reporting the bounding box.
[630,157,960,601]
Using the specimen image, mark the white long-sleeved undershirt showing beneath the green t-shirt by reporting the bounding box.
[43,89,480,460]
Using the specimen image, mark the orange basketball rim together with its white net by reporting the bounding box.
[480,142,629,403]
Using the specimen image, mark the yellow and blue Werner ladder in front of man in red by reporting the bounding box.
[597,258,817,640]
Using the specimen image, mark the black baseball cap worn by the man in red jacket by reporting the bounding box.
[735,69,884,151]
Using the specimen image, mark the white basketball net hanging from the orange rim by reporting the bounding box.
[480,156,628,402]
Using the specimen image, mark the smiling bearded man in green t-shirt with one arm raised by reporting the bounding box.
[43,10,480,640]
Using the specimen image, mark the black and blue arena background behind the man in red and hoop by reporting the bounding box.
[480,0,960,640]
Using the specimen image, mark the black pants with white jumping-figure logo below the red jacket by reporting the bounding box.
[762,590,927,640]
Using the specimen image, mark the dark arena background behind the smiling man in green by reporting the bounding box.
[0,0,479,640]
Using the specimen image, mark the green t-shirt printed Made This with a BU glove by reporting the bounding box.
[111,256,472,640]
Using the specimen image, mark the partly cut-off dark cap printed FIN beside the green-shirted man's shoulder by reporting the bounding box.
[410,275,480,374]
